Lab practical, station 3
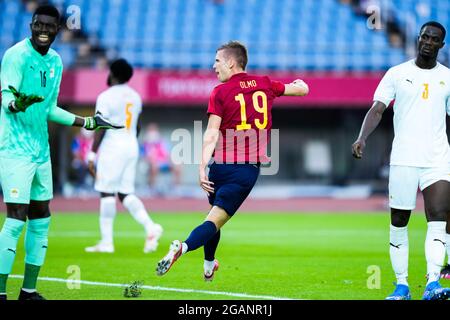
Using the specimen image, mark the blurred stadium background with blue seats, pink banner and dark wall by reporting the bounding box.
[0,0,450,205]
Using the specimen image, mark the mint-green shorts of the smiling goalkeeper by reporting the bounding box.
[0,157,53,204]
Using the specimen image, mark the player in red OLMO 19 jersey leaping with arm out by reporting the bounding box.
[156,41,309,281]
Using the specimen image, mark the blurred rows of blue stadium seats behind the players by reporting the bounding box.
[0,0,414,71]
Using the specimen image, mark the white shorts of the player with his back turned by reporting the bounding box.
[95,152,138,194]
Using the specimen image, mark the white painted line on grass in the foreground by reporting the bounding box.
[9,274,296,300]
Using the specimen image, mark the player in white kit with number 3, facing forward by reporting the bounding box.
[352,21,450,300]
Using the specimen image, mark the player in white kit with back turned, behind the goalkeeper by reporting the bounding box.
[86,59,162,253]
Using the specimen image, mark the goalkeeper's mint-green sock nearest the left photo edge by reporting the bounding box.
[0,218,25,293]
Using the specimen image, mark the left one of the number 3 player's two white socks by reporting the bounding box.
[389,225,409,286]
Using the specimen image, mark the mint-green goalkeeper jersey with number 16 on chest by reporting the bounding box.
[0,39,63,163]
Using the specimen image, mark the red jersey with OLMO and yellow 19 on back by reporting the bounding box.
[208,72,285,163]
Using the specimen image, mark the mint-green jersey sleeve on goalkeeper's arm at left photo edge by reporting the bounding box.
[1,50,24,113]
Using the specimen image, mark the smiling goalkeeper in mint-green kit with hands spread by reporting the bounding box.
[0,5,123,300]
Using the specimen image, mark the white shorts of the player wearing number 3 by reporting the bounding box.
[389,165,450,210]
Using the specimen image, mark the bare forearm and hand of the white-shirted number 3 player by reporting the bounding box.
[352,101,386,159]
